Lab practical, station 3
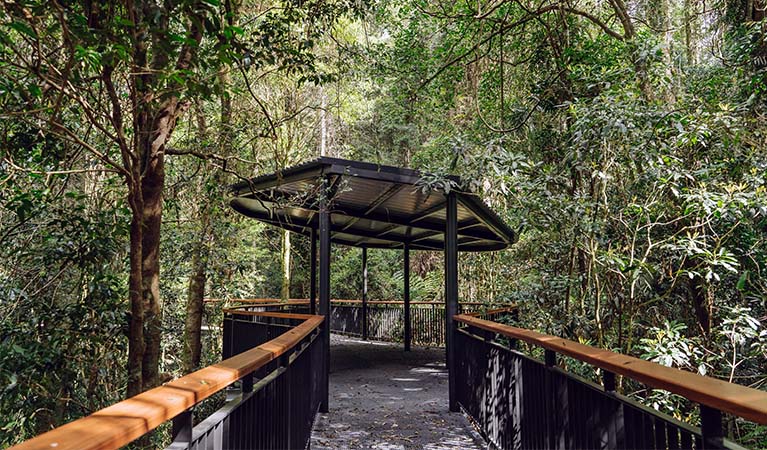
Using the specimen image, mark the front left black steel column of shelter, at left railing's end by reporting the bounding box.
[319,179,330,412]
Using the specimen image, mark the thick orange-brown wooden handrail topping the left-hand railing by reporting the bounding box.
[10,313,324,450]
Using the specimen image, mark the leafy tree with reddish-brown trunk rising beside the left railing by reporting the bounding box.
[0,0,358,396]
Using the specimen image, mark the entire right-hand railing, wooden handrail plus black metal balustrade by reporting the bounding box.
[453,315,767,449]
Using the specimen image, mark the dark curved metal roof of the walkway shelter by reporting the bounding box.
[230,157,516,251]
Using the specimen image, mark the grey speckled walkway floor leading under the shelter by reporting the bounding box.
[311,335,485,449]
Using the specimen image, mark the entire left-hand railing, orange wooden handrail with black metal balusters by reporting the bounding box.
[13,311,327,450]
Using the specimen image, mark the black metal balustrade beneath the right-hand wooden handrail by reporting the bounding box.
[453,316,756,449]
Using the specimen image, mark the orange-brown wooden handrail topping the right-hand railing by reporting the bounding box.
[455,314,767,425]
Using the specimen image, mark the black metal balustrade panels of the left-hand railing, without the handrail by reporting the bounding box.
[167,311,323,450]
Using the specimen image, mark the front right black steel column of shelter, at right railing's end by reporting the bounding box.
[445,192,458,412]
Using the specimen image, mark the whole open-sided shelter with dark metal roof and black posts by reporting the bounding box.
[230,157,516,410]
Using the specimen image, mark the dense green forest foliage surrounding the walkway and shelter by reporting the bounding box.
[0,0,767,447]
